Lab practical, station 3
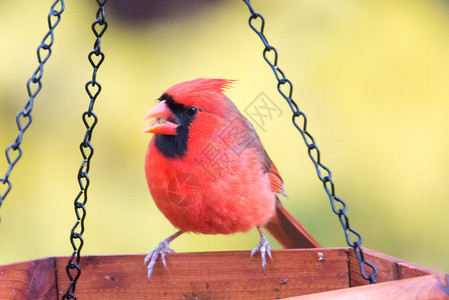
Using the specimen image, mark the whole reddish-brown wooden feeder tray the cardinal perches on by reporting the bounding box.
[0,248,449,300]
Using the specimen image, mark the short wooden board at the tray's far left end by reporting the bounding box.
[0,257,57,300]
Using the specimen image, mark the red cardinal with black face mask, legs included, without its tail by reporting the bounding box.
[143,78,316,279]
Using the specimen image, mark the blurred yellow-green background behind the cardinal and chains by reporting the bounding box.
[0,0,449,272]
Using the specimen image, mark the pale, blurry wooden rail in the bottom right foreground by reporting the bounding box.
[288,274,449,300]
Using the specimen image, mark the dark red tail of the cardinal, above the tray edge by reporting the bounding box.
[264,199,321,249]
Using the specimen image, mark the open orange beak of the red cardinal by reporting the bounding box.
[142,100,179,135]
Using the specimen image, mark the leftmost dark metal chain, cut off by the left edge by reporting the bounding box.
[0,0,65,220]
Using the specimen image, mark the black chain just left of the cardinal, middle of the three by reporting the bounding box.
[62,0,108,299]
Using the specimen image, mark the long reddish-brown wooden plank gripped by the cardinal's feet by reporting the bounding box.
[56,249,349,300]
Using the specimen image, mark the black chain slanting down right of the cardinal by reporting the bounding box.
[243,0,377,283]
